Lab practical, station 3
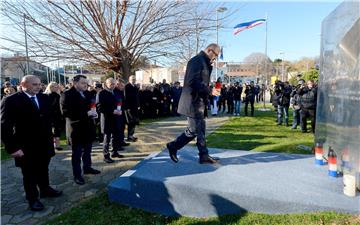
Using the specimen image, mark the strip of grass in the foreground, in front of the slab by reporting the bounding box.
[45,192,360,225]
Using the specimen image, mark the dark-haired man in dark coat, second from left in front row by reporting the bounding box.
[61,75,100,185]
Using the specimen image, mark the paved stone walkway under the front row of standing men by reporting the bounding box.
[1,117,229,224]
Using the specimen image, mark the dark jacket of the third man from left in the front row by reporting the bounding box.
[96,89,124,134]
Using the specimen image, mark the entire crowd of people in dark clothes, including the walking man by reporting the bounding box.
[1,61,317,211]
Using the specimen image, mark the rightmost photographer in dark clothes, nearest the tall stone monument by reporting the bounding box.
[297,80,317,133]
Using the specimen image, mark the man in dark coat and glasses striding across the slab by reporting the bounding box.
[166,44,220,163]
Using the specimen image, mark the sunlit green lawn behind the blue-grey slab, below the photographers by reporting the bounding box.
[207,104,314,154]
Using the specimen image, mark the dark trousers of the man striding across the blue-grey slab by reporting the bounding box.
[169,117,208,156]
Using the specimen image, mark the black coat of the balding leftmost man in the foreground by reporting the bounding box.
[1,92,55,166]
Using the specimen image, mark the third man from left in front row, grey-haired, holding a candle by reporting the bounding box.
[96,78,124,163]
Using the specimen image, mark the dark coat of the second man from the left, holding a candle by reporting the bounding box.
[60,87,95,144]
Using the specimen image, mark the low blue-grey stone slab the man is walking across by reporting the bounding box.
[108,147,360,217]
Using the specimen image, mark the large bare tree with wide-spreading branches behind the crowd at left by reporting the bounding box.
[1,0,221,78]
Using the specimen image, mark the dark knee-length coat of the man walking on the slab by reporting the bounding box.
[178,51,212,119]
